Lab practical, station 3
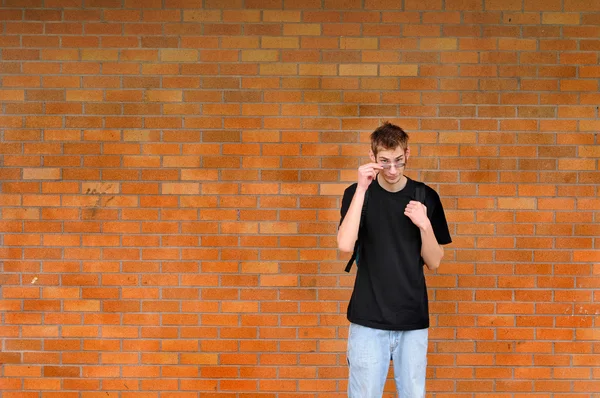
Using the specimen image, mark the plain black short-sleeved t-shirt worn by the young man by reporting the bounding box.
[340,178,452,330]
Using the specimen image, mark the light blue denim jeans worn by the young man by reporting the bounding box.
[347,323,429,398]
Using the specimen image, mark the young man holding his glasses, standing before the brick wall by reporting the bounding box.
[337,123,452,398]
